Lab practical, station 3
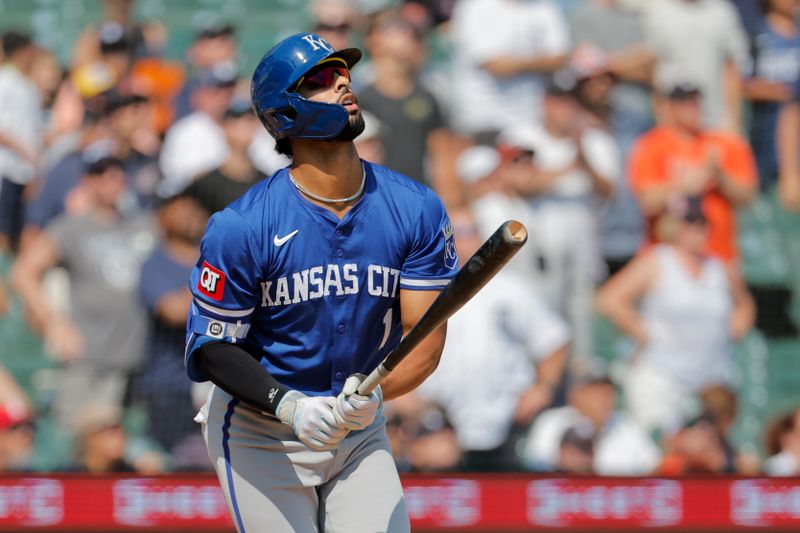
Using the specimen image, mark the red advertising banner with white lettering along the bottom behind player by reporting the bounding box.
[0,474,800,532]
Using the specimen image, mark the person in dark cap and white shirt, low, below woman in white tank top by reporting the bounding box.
[522,365,661,476]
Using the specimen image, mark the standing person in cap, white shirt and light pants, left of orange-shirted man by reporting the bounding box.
[498,71,621,368]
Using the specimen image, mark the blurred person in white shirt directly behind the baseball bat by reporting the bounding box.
[419,213,569,471]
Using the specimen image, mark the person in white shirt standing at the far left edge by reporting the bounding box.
[0,30,42,251]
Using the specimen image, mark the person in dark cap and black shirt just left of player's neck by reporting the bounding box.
[186,98,261,214]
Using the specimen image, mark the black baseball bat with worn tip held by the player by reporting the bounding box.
[358,220,528,396]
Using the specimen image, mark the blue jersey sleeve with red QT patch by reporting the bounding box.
[185,208,262,381]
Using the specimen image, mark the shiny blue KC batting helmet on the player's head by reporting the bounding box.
[250,33,361,139]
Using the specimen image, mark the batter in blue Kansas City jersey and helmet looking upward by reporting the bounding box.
[186,33,458,533]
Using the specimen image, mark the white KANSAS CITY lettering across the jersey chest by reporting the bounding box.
[261,263,400,307]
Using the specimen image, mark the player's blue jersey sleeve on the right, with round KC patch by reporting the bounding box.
[400,189,458,290]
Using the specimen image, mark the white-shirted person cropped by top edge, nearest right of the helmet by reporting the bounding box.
[451,0,569,142]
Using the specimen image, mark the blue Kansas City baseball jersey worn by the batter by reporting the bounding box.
[186,161,458,395]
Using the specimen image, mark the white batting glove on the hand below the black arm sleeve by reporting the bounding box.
[275,390,348,451]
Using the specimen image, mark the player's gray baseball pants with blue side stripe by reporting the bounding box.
[197,387,411,533]
